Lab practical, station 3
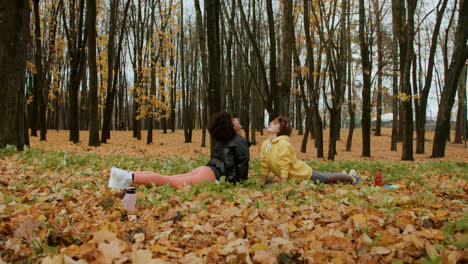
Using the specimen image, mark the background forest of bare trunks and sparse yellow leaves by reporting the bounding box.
[1,0,468,160]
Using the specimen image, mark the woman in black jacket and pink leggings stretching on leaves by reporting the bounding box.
[108,112,250,189]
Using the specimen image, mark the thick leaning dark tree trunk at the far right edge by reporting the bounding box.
[432,0,468,158]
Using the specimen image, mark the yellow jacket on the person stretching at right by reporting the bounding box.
[260,136,312,181]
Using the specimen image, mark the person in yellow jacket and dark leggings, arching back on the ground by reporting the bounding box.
[261,116,360,184]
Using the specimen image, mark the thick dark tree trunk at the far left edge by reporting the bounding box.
[0,0,30,150]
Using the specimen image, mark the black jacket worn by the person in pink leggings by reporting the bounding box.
[207,134,250,183]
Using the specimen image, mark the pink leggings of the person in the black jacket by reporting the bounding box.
[133,166,216,187]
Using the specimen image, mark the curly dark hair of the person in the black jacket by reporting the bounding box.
[208,112,236,142]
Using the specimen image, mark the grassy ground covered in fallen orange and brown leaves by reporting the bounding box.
[0,131,468,263]
